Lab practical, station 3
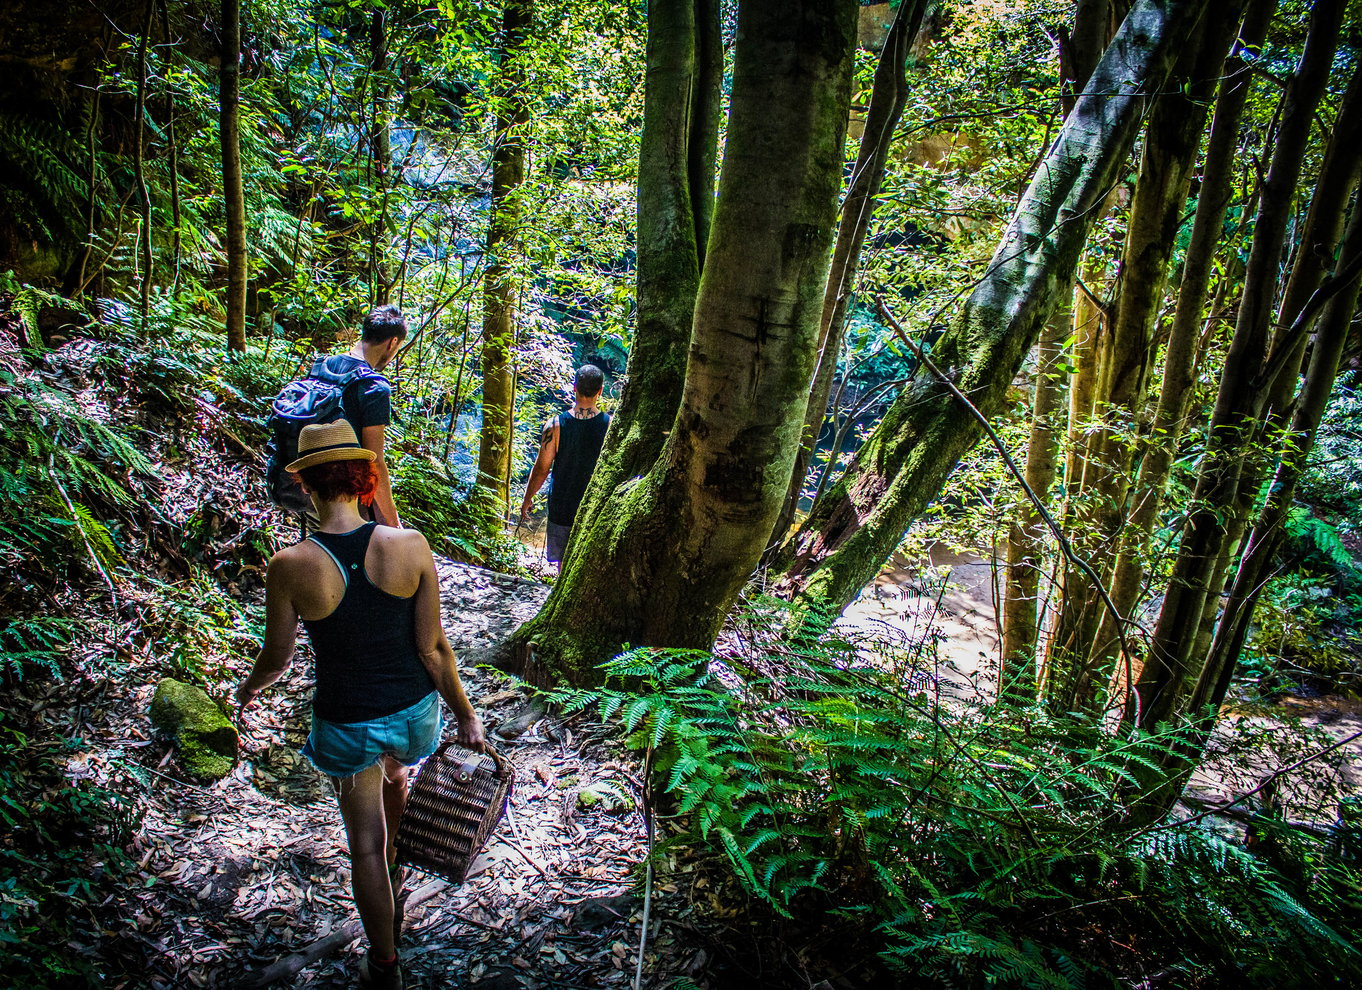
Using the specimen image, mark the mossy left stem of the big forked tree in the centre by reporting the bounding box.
[568,0,723,554]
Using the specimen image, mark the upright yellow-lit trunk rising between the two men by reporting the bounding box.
[478,0,533,516]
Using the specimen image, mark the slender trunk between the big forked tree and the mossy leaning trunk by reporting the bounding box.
[770,0,928,558]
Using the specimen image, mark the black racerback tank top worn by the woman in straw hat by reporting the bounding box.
[302,523,434,722]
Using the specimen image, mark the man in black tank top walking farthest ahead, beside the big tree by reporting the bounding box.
[520,365,610,564]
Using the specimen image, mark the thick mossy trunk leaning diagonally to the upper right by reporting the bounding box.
[783,0,1205,623]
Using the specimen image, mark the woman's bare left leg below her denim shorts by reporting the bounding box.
[336,764,396,959]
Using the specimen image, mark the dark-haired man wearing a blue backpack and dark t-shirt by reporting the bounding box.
[266,305,407,527]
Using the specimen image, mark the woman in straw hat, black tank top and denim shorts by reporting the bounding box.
[236,419,485,989]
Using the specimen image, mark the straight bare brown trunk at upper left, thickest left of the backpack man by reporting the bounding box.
[219,0,247,351]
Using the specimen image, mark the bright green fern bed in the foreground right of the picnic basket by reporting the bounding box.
[553,620,1362,987]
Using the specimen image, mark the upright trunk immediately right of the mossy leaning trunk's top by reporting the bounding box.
[1046,7,1238,711]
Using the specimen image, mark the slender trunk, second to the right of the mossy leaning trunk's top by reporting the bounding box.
[1094,0,1276,703]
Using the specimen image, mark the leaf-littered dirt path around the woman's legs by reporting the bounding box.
[91,561,704,990]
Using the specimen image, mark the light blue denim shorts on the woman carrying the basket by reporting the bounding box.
[302,690,444,778]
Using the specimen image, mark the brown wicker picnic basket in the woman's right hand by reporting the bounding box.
[396,741,515,884]
